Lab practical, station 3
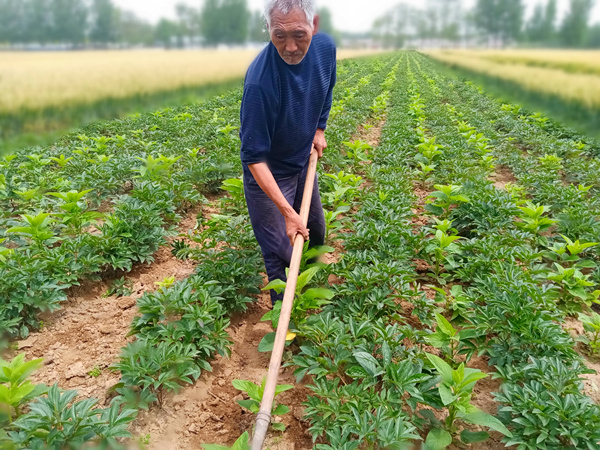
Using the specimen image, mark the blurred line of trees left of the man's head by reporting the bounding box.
[0,0,267,48]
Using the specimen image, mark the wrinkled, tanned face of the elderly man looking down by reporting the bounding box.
[269,9,319,65]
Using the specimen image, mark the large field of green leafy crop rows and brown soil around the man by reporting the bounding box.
[0,52,600,450]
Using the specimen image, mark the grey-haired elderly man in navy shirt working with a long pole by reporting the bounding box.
[240,0,336,303]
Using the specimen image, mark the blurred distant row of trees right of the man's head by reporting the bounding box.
[373,0,600,48]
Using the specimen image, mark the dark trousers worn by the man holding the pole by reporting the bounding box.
[244,164,325,303]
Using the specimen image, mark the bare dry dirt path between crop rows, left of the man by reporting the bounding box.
[17,207,200,405]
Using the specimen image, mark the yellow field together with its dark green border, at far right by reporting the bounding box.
[427,50,600,138]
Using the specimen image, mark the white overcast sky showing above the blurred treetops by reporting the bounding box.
[113,0,600,31]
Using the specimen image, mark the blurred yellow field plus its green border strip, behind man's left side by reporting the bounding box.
[0,50,380,154]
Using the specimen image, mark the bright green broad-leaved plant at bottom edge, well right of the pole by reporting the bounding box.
[419,353,512,450]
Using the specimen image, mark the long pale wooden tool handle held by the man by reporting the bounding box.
[252,151,319,450]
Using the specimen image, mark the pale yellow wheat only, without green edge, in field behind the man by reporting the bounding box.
[0,49,372,114]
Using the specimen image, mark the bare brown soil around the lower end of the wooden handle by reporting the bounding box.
[131,293,313,450]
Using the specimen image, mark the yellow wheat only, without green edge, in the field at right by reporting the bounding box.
[425,50,600,108]
